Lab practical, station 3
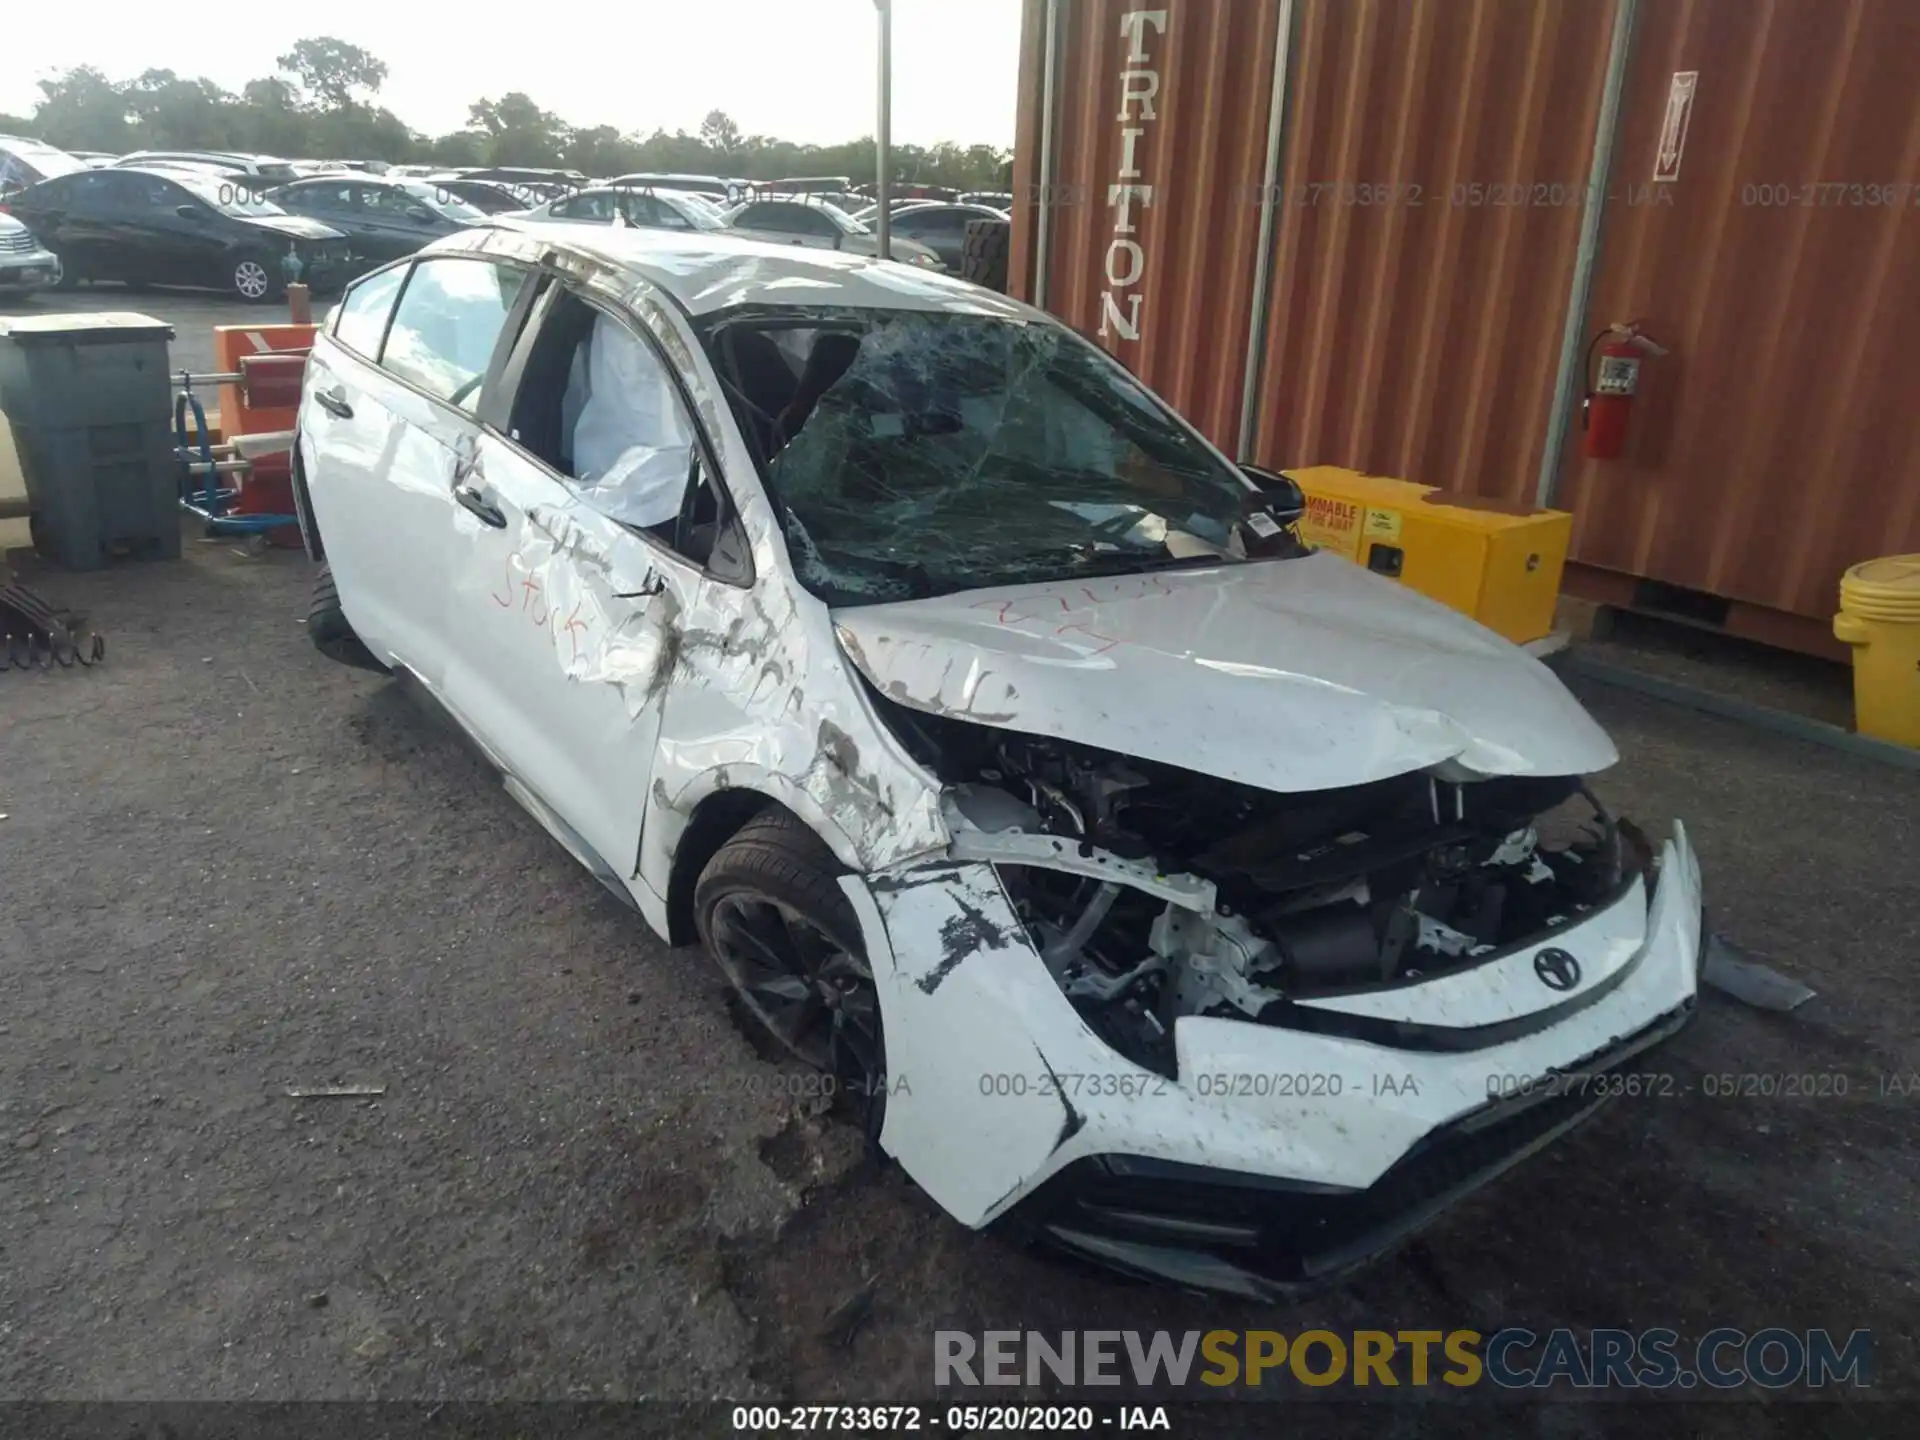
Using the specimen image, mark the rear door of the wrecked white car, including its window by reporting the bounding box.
[300,255,532,689]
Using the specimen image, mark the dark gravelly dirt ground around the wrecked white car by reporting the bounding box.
[0,538,1920,1436]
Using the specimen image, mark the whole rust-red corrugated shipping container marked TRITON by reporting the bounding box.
[1014,0,1920,655]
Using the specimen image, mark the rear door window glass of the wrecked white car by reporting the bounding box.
[380,257,524,409]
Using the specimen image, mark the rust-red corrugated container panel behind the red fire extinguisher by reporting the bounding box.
[1559,0,1920,616]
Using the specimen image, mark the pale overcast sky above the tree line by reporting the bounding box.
[0,0,1020,150]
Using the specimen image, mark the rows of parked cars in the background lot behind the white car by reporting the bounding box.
[0,142,1006,301]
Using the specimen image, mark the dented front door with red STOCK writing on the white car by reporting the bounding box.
[444,280,751,891]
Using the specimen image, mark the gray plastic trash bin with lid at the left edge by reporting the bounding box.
[0,311,180,570]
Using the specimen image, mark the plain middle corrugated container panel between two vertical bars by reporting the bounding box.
[1256,0,1613,501]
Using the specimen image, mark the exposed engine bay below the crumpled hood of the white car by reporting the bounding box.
[883,701,1651,1075]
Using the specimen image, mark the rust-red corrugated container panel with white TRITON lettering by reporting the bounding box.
[1012,0,1279,449]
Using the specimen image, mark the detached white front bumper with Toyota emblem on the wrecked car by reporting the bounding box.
[843,824,1701,1294]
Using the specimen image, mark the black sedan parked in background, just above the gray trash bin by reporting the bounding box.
[8,165,349,300]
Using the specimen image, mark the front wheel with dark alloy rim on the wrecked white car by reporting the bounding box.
[693,810,887,1140]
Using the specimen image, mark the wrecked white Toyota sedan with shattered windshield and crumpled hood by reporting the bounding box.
[296,225,1701,1296]
